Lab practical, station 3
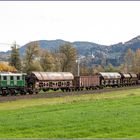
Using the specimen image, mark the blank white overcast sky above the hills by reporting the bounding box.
[0,1,140,51]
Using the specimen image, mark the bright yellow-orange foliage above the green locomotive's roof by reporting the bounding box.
[0,62,17,72]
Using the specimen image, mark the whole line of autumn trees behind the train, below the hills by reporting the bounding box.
[9,42,140,75]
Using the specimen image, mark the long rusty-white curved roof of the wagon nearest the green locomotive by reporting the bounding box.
[32,72,74,80]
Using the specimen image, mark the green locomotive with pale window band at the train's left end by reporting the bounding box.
[0,72,26,96]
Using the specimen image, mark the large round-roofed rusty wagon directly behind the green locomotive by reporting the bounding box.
[28,72,74,91]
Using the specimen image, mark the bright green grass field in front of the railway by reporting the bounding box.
[0,89,140,138]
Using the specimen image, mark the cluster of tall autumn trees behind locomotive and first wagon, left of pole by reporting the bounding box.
[9,42,77,73]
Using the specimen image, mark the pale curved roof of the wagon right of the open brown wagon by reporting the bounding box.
[99,72,121,79]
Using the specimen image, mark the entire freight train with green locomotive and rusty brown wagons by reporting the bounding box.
[0,72,140,96]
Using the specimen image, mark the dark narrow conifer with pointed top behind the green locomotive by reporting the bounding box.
[9,43,21,71]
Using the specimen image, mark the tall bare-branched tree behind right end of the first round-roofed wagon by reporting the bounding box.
[59,43,77,72]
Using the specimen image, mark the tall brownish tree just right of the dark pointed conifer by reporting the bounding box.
[23,42,42,73]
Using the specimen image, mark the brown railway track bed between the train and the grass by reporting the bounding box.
[0,85,140,102]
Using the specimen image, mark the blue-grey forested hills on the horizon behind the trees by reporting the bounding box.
[0,36,140,66]
